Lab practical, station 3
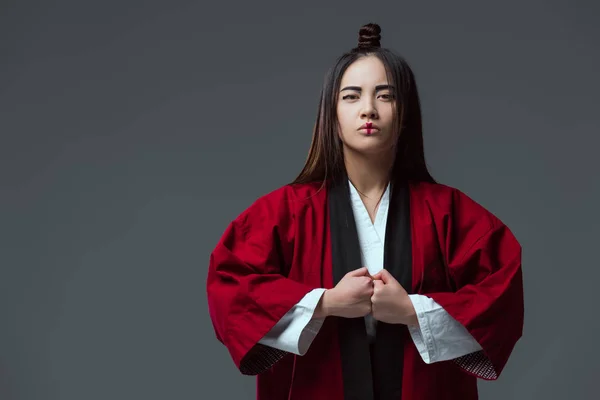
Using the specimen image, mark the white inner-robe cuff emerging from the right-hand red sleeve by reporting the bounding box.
[408,294,481,364]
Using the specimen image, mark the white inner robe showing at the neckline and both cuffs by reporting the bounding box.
[260,183,481,364]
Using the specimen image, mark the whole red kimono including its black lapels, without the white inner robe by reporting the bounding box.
[207,183,524,400]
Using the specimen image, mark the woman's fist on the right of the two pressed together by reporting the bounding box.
[371,269,418,325]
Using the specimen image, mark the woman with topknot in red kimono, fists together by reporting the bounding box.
[207,24,523,400]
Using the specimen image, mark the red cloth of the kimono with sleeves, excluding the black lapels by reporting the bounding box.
[207,183,523,400]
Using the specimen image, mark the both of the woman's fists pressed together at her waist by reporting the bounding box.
[316,267,417,325]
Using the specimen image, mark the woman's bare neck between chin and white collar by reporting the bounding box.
[344,149,393,196]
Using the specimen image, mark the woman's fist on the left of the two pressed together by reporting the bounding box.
[315,267,373,318]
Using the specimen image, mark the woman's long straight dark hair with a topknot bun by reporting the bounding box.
[292,24,435,184]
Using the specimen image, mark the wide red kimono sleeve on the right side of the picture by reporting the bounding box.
[427,191,524,380]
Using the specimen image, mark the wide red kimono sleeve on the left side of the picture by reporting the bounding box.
[206,191,313,375]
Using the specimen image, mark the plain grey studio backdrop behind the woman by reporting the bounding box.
[0,0,600,400]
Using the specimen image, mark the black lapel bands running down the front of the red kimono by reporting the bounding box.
[328,178,412,400]
